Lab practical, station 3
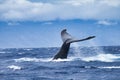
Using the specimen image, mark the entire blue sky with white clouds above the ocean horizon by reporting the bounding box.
[0,0,120,48]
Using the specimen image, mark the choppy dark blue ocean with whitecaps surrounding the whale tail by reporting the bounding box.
[0,46,120,80]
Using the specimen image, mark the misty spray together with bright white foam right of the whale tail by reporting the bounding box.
[70,41,120,62]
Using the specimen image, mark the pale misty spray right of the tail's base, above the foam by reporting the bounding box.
[72,42,104,58]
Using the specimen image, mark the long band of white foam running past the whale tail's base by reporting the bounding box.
[14,54,120,62]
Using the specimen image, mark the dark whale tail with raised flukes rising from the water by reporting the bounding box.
[53,29,95,59]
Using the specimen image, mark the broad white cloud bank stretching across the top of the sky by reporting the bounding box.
[0,0,120,21]
